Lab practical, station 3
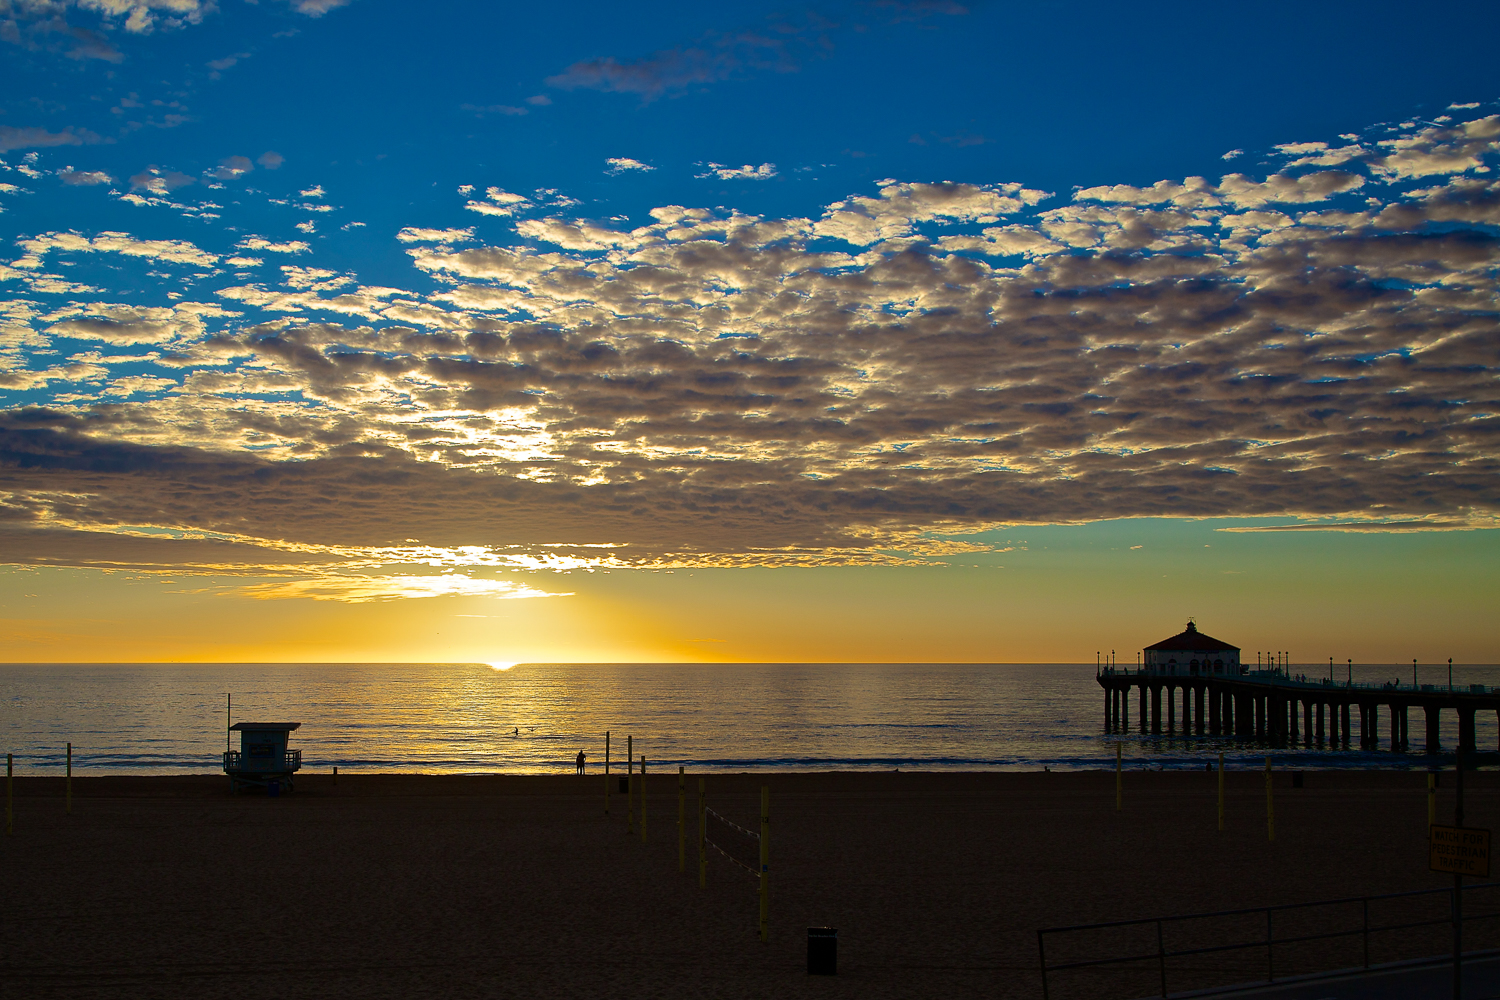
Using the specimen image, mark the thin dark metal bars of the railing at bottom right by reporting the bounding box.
[1037,882,1500,1000]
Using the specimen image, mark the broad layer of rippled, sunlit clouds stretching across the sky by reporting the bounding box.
[0,109,1500,600]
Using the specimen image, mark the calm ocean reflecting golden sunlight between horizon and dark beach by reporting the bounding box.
[0,663,1500,775]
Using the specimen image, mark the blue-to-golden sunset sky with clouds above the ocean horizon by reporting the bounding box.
[0,0,1500,664]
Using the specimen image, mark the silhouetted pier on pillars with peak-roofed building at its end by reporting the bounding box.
[1097,622,1500,753]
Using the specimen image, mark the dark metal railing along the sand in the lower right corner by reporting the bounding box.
[1037,882,1500,1000]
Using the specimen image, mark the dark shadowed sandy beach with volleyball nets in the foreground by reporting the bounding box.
[0,772,1500,997]
